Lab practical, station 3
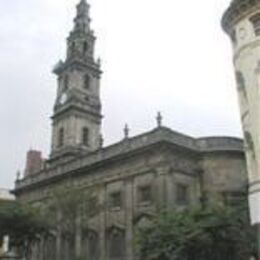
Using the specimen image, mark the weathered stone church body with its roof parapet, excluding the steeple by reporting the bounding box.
[16,127,247,260]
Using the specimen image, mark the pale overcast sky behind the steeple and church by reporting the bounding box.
[0,0,241,188]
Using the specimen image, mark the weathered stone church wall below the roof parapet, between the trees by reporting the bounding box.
[14,140,246,260]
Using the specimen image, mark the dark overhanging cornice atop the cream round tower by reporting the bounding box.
[221,0,260,33]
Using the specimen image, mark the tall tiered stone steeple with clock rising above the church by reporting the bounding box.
[50,0,102,159]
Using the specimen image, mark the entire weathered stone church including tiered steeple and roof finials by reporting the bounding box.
[15,0,247,260]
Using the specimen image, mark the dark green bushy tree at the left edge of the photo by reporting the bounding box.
[0,201,49,259]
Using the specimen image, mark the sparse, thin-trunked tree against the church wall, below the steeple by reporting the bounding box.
[45,186,101,259]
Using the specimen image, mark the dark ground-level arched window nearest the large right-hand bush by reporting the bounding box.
[108,228,126,260]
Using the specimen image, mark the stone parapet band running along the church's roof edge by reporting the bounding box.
[15,127,244,192]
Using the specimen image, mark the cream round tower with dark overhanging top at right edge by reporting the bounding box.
[222,0,260,225]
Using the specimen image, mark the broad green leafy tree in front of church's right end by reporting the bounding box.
[137,201,256,260]
